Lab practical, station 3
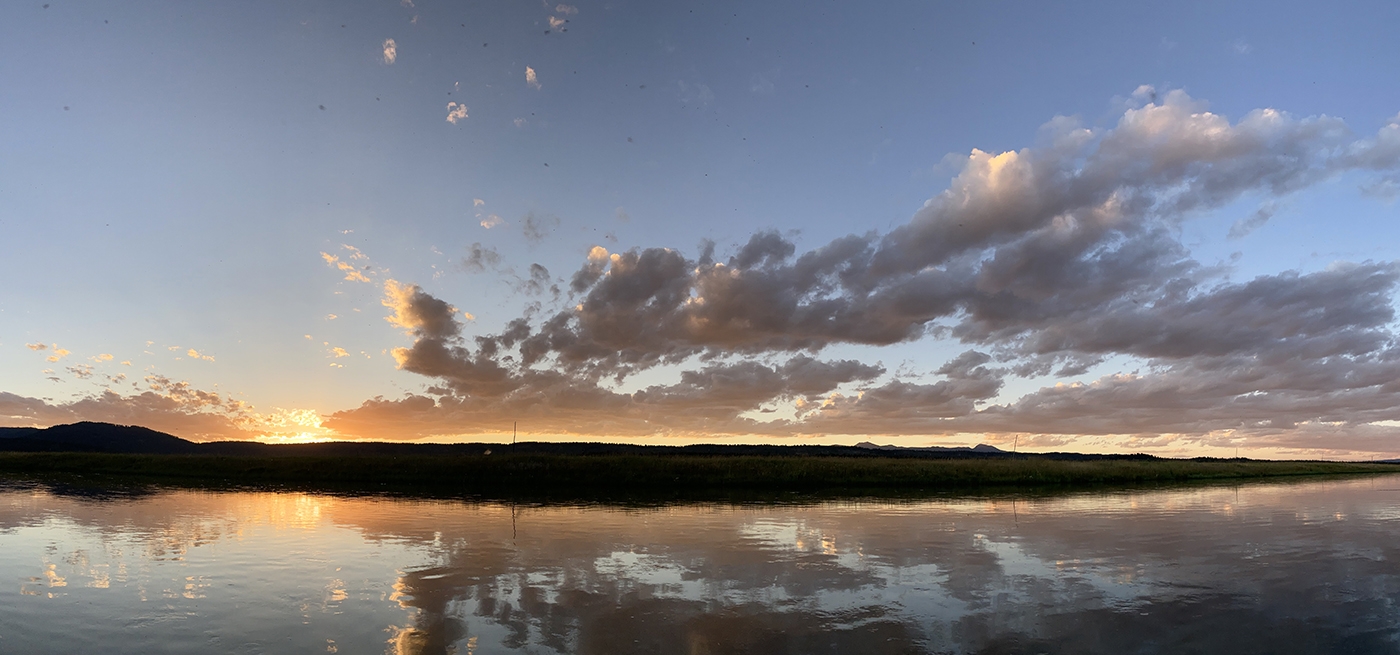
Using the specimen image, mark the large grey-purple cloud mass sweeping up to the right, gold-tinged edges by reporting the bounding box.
[329,87,1400,453]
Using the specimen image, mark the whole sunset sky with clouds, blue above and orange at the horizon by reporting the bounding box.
[0,0,1400,459]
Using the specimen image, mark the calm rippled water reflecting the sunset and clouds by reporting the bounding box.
[0,477,1400,655]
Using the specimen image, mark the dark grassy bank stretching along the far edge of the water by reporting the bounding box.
[0,452,1400,495]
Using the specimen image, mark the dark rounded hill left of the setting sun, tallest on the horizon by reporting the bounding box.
[0,421,200,455]
